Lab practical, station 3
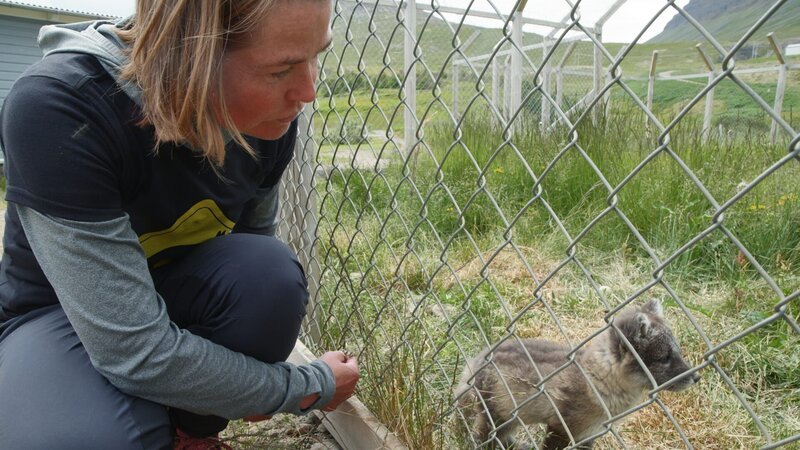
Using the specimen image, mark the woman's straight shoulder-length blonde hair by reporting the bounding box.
[120,0,278,167]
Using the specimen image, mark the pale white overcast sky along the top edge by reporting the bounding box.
[26,0,689,42]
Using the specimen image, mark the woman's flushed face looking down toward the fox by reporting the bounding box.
[222,0,331,139]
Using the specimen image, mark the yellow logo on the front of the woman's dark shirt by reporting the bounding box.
[139,199,235,258]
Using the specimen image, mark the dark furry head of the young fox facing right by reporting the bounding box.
[612,299,700,391]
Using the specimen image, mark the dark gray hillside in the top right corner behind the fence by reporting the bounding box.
[648,0,800,43]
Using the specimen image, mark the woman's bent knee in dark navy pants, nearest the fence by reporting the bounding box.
[156,234,308,362]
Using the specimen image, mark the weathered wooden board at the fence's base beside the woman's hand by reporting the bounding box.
[289,340,408,450]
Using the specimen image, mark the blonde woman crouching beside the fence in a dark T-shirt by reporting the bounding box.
[0,0,358,449]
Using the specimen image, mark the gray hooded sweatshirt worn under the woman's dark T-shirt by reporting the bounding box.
[14,21,335,419]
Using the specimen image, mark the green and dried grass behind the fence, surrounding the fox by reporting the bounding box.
[306,100,800,448]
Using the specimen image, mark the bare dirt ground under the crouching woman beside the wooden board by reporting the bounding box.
[0,200,341,450]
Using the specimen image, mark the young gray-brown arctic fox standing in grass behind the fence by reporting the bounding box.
[455,300,700,449]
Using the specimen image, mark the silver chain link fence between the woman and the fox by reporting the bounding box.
[281,0,800,449]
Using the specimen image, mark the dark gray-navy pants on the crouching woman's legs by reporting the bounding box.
[0,234,308,450]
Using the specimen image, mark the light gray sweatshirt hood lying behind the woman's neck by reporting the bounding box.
[38,17,141,106]
